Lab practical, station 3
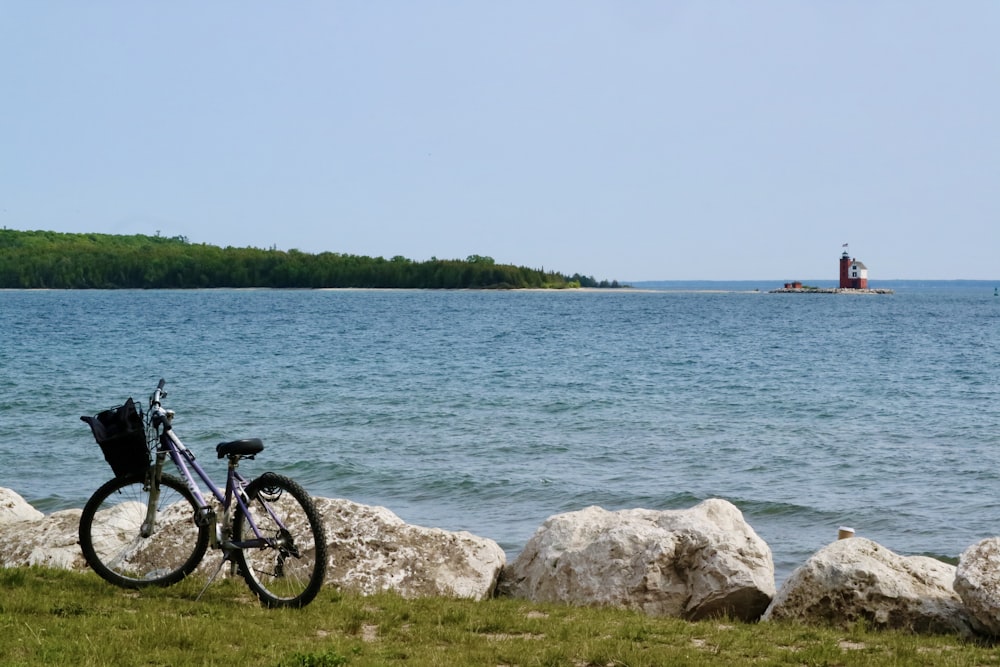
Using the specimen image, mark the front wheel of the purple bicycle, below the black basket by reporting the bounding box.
[80,473,209,588]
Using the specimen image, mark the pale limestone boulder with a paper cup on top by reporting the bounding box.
[763,537,976,635]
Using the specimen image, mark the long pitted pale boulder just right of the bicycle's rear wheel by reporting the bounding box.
[316,498,506,600]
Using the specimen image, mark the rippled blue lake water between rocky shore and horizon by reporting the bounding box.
[0,283,1000,582]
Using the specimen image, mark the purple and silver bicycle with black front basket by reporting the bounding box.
[80,379,327,607]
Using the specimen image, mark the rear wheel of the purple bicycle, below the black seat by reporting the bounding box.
[233,472,327,607]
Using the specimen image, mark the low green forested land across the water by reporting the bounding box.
[0,228,619,289]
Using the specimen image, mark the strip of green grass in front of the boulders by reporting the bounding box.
[0,568,1000,667]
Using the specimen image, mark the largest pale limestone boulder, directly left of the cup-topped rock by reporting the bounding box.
[501,499,775,620]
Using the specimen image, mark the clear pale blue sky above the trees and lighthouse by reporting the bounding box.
[0,0,1000,286]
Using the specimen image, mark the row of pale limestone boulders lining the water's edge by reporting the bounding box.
[0,488,1000,637]
